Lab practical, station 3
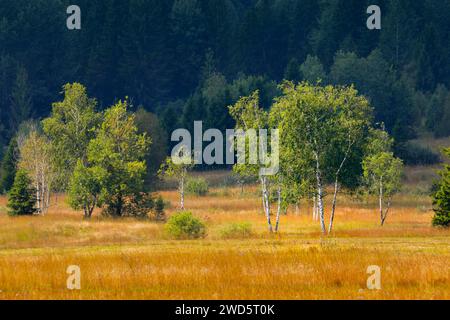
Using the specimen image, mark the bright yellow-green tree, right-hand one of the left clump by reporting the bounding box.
[87,101,149,217]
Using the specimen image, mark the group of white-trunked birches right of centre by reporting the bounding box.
[229,81,402,234]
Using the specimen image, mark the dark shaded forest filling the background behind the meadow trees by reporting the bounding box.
[0,0,450,163]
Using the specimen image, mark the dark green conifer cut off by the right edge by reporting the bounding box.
[433,148,450,227]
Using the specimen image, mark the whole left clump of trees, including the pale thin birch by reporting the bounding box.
[4,83,164,220]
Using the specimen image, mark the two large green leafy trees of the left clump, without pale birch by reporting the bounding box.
[59,84,150,217]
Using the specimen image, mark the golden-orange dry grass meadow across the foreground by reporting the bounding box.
[0,172,450,299]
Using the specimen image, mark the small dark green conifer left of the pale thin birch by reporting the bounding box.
[8,170,36,216]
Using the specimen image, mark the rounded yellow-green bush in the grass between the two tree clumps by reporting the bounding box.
[165,211,206,239]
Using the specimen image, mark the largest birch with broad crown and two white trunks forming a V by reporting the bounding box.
[272,82,372,234]
